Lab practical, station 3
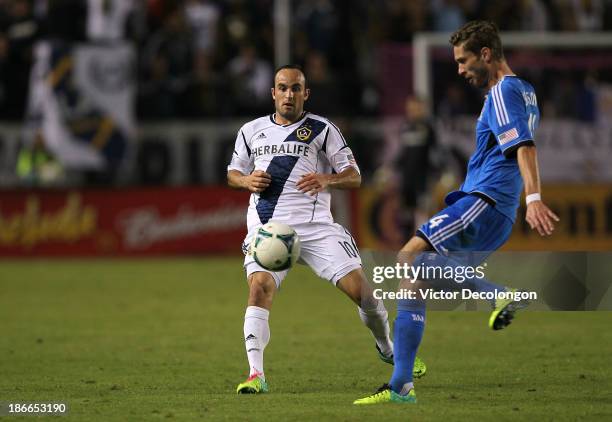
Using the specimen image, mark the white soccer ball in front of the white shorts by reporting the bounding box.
[250,221,300,271]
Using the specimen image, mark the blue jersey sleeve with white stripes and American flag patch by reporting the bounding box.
[489,82,538,157]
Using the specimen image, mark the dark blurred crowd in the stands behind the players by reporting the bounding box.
[0,0,612,120]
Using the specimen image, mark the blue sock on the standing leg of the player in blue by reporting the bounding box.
[389,299,425,393]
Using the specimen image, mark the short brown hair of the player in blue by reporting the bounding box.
[449,21,504,60]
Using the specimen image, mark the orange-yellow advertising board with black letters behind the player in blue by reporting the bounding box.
[355,184,612,251]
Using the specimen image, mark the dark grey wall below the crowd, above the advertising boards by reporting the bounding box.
[0,117,612,188]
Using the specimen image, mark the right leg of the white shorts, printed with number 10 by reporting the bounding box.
[298,223,361,285]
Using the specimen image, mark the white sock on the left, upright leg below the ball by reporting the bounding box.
[244,306,270,379]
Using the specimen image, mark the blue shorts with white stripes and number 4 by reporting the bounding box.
[416,195,512,261]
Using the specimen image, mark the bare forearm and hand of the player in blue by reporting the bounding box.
[517,146,559,236]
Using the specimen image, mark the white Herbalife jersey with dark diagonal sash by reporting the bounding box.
[227,112,359,232]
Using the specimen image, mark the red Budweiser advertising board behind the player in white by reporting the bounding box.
[0,187,249,256]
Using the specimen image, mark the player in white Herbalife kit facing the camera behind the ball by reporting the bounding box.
[227,65,425,394]
